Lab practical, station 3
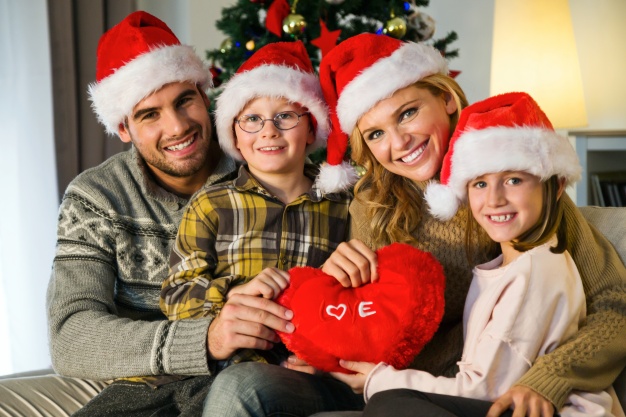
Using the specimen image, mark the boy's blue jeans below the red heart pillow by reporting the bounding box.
[202,362,365,417]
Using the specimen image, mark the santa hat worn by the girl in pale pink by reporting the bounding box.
[425,93,582,220]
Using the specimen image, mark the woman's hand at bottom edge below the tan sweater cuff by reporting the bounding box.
[486,385,554,417]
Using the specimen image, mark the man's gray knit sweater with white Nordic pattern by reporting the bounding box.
[47,148,236,380]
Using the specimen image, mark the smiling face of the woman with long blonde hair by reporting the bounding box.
[357,85,457,181]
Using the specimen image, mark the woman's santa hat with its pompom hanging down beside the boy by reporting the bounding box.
[317,33,448,192]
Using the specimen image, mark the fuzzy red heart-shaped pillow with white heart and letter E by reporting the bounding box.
[277,243,445,373]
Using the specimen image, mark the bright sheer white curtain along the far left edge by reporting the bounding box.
[0,0,59,375]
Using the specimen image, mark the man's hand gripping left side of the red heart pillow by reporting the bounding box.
[207,294,295,360]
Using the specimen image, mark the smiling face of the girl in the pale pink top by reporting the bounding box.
[467,171,543,245]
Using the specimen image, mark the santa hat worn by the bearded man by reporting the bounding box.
[89,11,211,135]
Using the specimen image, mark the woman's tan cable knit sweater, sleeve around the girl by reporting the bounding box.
[350,188,626,409]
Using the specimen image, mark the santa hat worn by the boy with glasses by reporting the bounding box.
[215,41,329,161]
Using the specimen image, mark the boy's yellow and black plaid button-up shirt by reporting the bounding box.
[161,166,351,362]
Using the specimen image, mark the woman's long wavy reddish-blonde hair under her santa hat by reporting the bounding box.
[350,74,468,246]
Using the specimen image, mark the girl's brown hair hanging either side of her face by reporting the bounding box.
[465,175,567,263]
